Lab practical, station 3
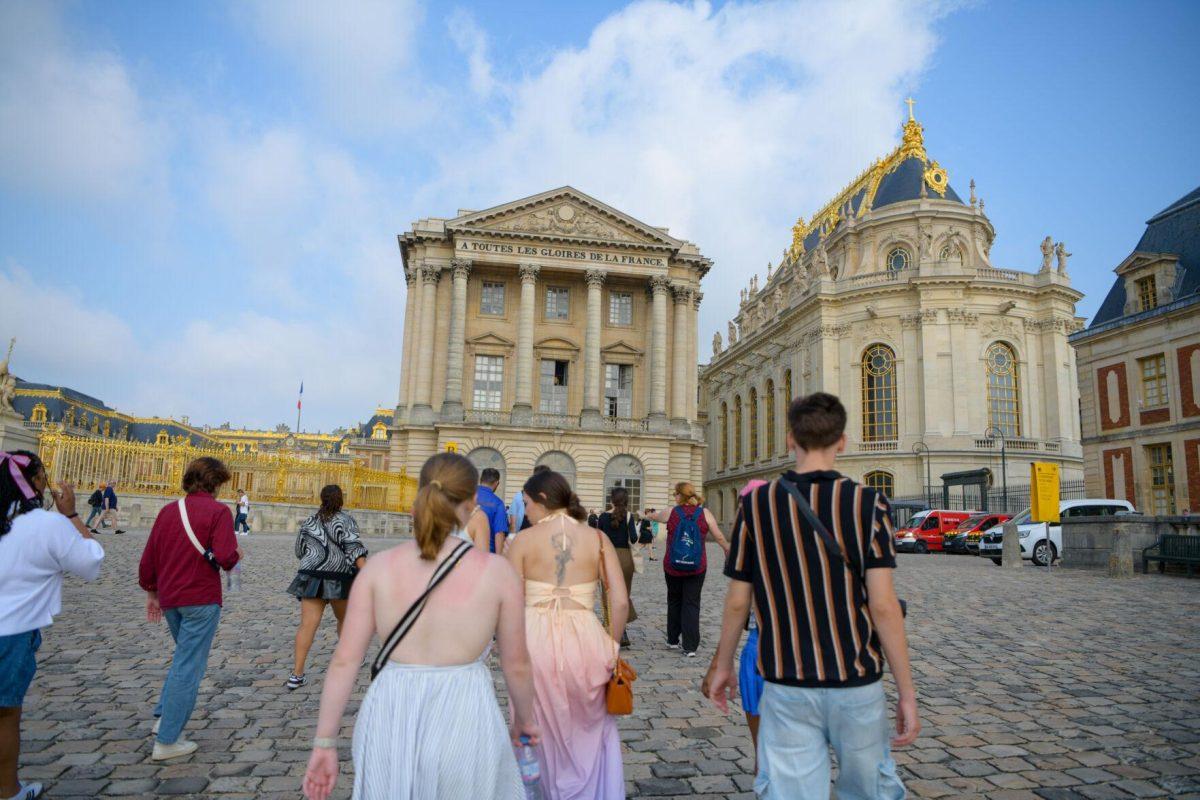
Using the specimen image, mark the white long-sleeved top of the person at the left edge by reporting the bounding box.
[0,509,104,636]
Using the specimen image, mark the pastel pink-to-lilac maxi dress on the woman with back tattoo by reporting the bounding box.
[526,581,625,800]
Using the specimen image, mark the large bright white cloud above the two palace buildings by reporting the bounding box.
[428,0,937,352]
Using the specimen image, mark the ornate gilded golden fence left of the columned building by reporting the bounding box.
[41,432,416,512]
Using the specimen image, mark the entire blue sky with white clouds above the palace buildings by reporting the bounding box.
[0,0,1200,428]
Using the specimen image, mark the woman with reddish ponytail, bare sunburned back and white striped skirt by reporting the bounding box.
[304,452,540,800]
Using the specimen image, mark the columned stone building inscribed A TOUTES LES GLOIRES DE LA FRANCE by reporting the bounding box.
[390,187,710,507]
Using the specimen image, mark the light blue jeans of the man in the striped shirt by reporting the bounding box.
[754,681,906,800]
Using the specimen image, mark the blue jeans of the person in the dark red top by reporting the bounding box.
[154,603,221,745]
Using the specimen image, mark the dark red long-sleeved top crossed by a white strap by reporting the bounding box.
[138,492,239,608]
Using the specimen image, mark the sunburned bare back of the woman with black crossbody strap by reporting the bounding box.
[371,539,496,666]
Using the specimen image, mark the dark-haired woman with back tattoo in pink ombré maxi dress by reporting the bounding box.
[500,470,629,800]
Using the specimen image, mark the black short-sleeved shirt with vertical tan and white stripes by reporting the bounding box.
[725,471,896,687]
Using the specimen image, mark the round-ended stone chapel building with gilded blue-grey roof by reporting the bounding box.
[701,106,1082,519]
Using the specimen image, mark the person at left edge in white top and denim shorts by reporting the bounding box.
[0,450,104,800]
